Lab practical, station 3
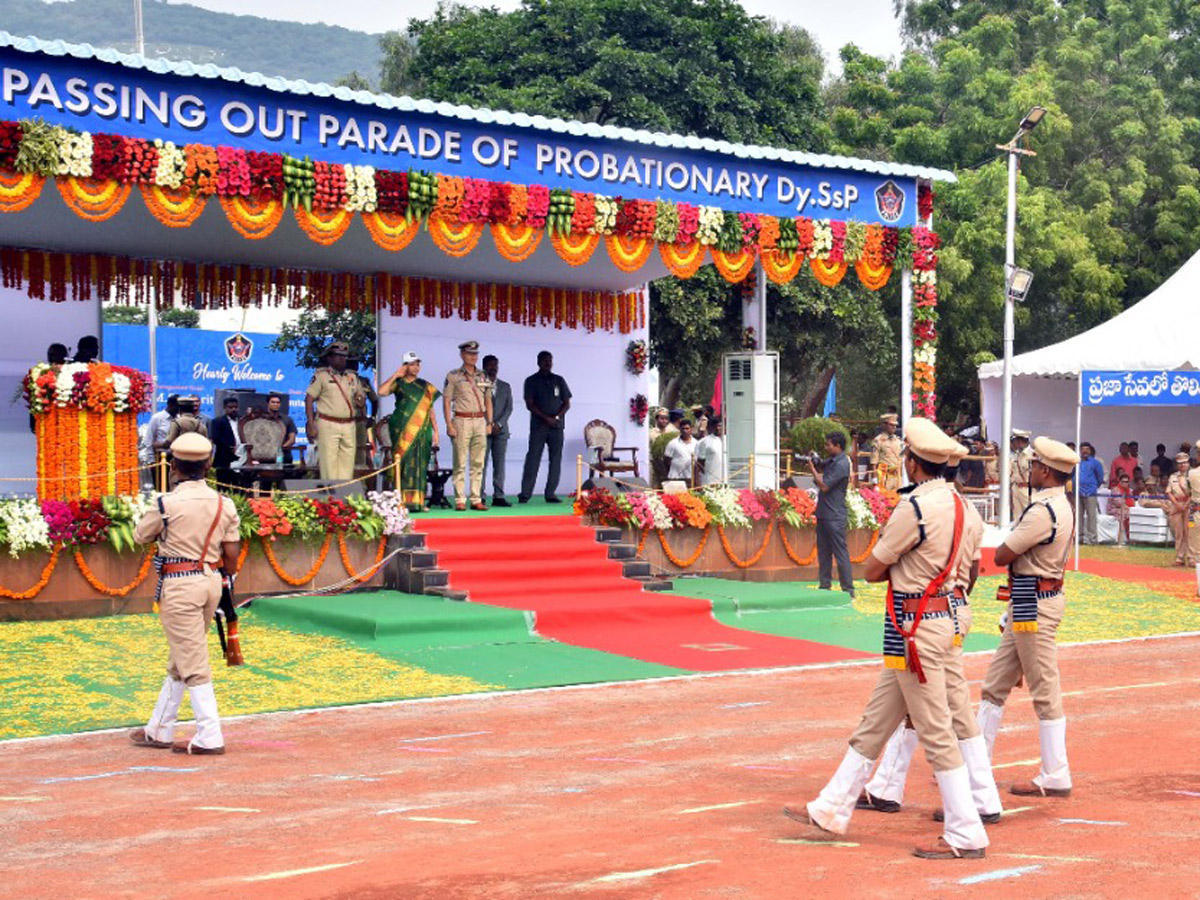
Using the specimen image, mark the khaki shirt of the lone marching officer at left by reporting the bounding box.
[133,481,241,563]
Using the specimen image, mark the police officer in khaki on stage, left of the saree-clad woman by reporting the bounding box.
[304,341,366,481]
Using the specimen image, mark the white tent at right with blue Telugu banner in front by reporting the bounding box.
[979,253,1200,475]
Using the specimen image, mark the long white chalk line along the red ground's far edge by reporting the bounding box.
[9,631,1200,746]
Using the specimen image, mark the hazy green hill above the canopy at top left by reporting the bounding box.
[0,0,380,84]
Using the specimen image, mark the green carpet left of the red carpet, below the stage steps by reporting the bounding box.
[251,590,686,689]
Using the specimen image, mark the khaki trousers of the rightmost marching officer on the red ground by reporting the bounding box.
[982,594,1067,721]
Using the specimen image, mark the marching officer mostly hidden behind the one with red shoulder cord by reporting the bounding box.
[858,446,1002,824]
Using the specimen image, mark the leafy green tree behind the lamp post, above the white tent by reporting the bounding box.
[827,0,1200,419]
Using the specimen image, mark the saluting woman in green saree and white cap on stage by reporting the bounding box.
[379,350,442,511]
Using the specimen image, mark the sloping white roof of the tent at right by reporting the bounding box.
[979,253,1200,379]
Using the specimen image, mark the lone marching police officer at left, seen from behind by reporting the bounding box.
[130,433,239,755]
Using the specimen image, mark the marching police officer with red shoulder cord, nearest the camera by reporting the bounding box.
[784,418,988,859]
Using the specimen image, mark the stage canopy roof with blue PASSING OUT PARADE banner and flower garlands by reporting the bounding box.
[0,32,955,292]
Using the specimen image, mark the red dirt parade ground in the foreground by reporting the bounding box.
[0,637,1200,900]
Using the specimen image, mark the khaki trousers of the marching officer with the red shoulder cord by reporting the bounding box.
[850,618,962,772]
